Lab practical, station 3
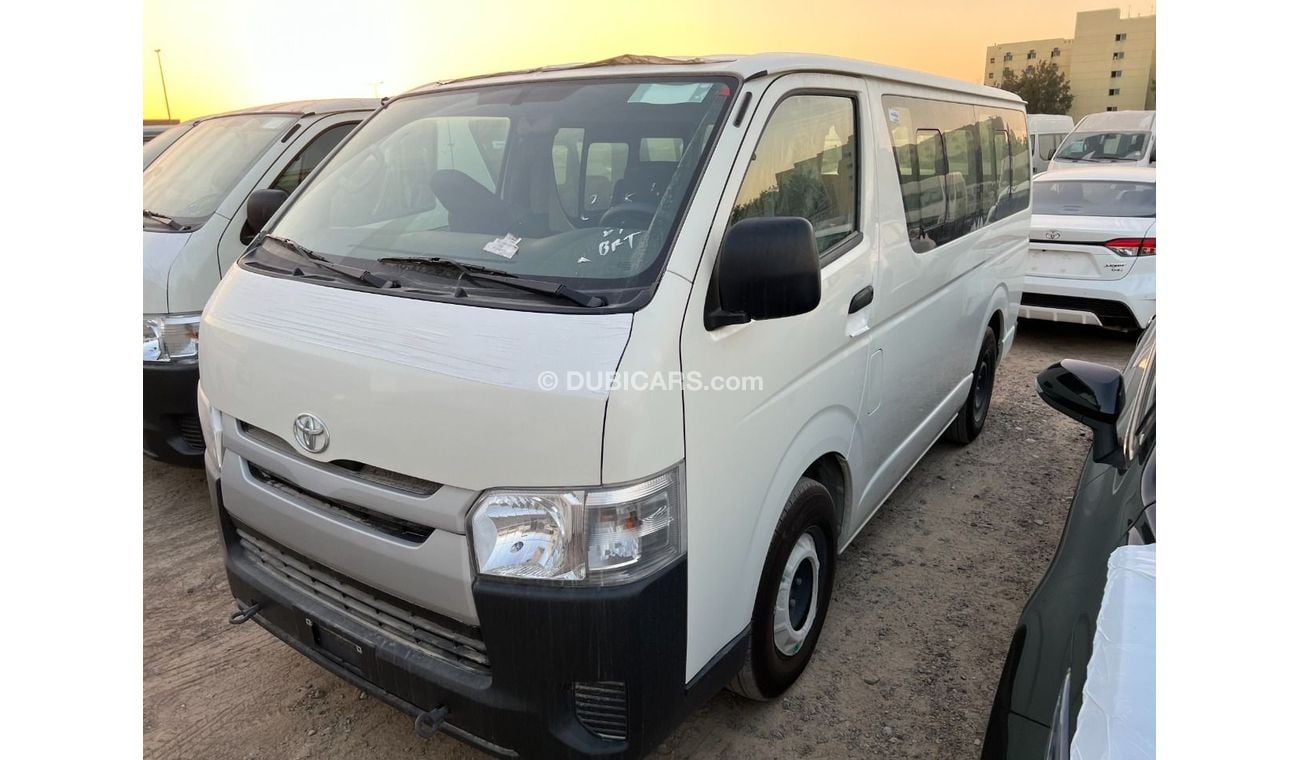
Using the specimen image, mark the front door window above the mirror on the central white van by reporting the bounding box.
[729,95,858,253]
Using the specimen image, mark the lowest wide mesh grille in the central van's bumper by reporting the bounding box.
[235,525,491,673]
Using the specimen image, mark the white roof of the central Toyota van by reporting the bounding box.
[399,53,1024,104]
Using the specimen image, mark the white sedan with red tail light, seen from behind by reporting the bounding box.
[1021,165,1156,330]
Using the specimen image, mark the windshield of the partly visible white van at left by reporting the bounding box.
[144,114,298,225]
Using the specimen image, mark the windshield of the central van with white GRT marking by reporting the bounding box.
[273,78,732,300]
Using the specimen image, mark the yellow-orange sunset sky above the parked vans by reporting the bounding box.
[140,0,1154,120]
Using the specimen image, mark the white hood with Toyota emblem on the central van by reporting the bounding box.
[199,265,632,490]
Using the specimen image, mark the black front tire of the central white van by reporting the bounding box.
[728,478,836,702]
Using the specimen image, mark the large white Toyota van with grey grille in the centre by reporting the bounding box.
[199,55,1030,757]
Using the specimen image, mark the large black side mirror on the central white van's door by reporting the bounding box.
[705,217,822,330]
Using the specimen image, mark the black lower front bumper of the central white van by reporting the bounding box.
[209,470,745,757]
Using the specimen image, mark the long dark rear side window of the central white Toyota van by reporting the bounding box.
[881,95,1030,253]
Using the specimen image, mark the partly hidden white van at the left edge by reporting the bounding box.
[143,100,380,466]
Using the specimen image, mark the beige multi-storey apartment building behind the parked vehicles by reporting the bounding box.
[984,8,1156,121]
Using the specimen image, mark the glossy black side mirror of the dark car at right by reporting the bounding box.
[1037,359,1127,469]
